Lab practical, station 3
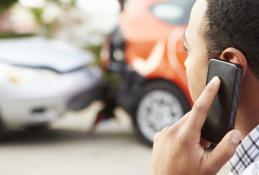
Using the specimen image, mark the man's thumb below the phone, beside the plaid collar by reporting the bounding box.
[205,130,241,174]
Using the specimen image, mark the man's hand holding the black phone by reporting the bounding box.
[152,77,241,175]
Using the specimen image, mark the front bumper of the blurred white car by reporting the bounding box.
[0,68,102,128]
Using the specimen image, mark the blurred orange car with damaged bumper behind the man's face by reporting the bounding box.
[103,0,195,144]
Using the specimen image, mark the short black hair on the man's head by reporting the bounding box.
[206,0,259,78]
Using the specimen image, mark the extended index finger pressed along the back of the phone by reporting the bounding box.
[189,77,220,130]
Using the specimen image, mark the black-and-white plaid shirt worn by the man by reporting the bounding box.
[229,125,259,175]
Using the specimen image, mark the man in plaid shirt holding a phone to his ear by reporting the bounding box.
[152,0,259,175]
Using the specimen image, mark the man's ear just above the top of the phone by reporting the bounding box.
[220,47,248,77]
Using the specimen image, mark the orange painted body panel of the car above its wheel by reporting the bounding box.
[119,0,192,105]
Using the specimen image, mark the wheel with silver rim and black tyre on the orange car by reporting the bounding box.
[132,81,190,146]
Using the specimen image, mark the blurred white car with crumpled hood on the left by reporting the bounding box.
[0,37,102,129]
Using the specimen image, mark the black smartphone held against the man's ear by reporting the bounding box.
[201,59,243,145]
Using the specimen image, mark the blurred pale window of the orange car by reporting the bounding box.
[151,0,194,25]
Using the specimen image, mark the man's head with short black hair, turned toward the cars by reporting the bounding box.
[185,0,259,100]
